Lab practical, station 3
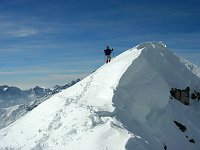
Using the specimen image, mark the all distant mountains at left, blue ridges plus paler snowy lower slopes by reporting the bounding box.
[0,79,80,129]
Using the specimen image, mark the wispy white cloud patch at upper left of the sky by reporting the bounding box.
[0,14,60,40]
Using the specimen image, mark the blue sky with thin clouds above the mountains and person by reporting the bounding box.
[0,0,200,89]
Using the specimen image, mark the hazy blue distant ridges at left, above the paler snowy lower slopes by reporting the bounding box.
[0,79,80,108]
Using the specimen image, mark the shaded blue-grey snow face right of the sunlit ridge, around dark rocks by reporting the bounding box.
[113,43,200,150]
